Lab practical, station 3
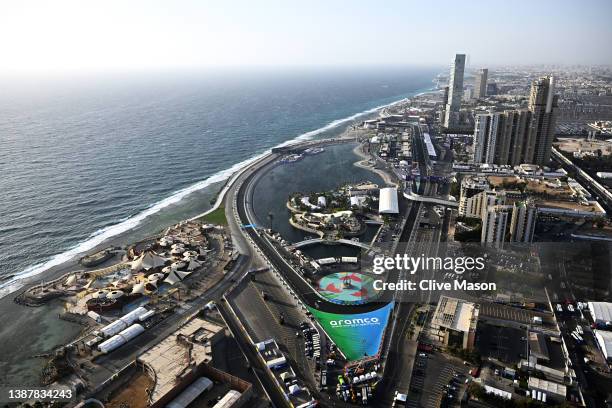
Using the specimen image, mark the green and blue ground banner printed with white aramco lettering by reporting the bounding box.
[309,303,393,361]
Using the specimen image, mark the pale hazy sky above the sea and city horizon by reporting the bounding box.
[0,0,612,72]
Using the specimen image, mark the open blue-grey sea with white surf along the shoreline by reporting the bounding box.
[0,68,437,294]
